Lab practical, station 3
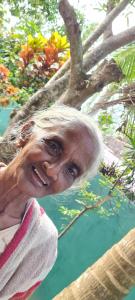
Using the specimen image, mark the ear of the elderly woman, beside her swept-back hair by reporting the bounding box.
[16,120,35,148]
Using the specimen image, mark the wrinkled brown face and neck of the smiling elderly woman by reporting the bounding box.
[0,122,94,228]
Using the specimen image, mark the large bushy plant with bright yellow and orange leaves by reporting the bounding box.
[19,32,70,87]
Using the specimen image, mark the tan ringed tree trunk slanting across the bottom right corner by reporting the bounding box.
[53,229,135,300]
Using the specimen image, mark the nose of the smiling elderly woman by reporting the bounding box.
[43,162,61,181]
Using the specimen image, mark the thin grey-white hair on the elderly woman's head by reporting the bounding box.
[31,104,103,182]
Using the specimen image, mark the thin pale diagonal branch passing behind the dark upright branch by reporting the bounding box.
[47,0,129,86]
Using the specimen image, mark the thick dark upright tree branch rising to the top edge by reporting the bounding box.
[59,0,83,89]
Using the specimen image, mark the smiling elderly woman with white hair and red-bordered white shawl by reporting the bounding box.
[0,106,102,300]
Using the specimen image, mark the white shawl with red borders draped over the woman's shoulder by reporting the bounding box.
[0,199,58,300]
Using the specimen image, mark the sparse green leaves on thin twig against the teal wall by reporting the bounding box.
[59,174,127,225]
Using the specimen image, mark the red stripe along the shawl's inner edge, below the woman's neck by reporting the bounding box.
[0,201,34,268]
